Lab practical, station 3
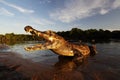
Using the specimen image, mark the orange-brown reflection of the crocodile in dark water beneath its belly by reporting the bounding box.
[54,56,83,72]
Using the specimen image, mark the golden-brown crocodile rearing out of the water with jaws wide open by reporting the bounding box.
[24,26,97,57]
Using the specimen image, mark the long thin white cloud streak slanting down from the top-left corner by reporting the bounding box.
[0,0,34,13]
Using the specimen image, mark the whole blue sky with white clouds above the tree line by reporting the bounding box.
[0,0,120,34]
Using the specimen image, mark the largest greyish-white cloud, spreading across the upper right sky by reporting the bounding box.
[50,0,120,23]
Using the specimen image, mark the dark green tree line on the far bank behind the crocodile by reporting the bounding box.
[0,28,120,44]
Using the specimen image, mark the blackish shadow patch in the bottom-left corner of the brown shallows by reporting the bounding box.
[0,64,29,80]
